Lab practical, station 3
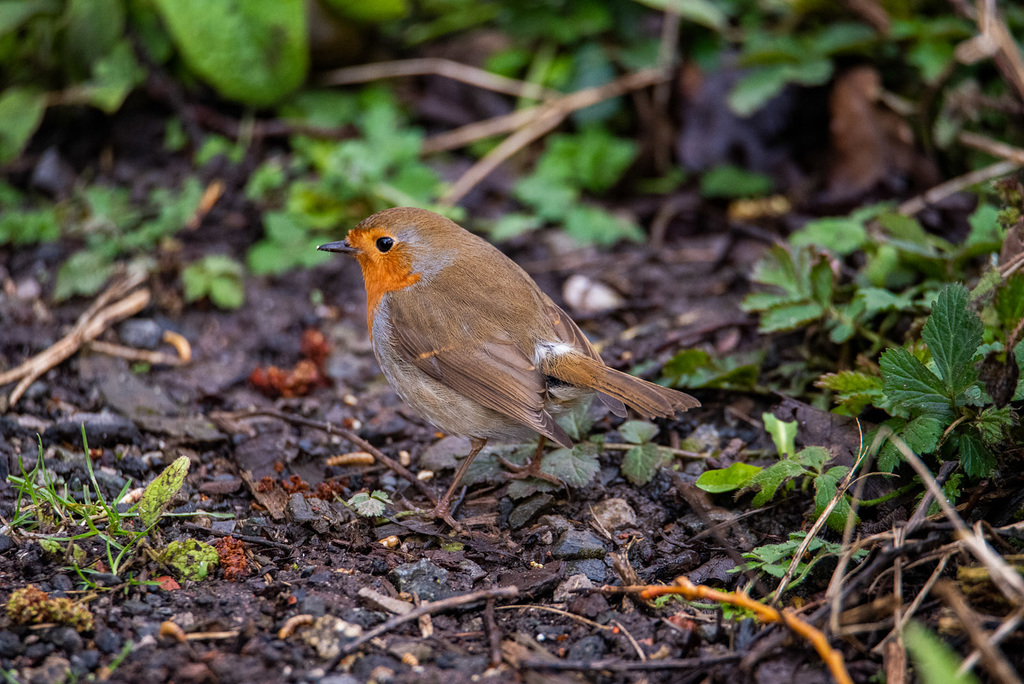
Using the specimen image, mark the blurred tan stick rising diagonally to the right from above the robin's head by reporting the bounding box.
[440,69,668,206]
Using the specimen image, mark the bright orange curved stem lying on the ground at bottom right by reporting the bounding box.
[618,576,853,684]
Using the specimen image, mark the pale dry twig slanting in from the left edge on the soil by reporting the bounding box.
[0,275,150,409]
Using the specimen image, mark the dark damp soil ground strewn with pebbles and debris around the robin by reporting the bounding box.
[0,88,1020,684]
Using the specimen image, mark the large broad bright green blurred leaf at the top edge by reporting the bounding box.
[154,0,309,106]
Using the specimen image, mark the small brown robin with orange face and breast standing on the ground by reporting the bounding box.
[318,207,700,527]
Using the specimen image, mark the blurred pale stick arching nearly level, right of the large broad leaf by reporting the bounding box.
[319,57,562,99]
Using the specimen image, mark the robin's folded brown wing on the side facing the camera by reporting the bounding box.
[391,290,572,446]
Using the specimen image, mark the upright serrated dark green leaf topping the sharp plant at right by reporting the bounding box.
[921,284,985,394]
